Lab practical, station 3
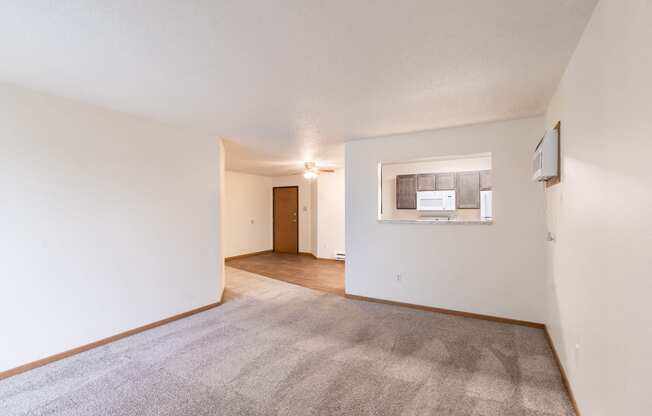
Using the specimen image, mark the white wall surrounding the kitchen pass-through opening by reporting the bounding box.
[346,118,545,322]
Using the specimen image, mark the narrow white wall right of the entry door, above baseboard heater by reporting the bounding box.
[315,169,345,259]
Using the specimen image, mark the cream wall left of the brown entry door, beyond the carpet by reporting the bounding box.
[224,171,273,257]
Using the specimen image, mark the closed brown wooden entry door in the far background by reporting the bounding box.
[274,186,299,253]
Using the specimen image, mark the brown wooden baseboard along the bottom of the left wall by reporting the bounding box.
[0,302,221,380]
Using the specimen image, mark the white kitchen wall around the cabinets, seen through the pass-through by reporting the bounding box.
[381,156,491,221]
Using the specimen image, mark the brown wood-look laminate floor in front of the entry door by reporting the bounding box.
[226,253,344,296]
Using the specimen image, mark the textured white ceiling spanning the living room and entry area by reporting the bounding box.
[0,0,596,174]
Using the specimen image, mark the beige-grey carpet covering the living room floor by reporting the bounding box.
[0,268,573,416]
